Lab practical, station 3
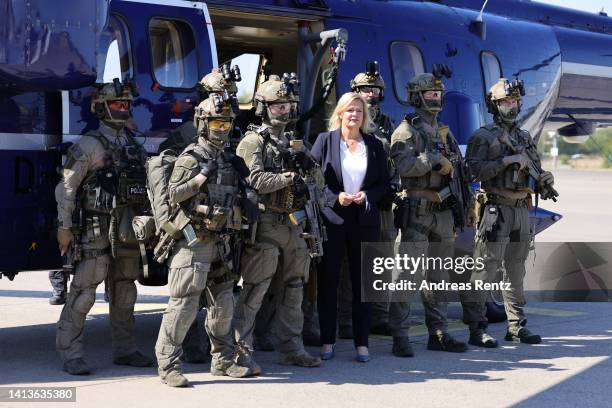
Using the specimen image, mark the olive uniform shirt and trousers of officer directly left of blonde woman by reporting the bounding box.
[234,128,310,361]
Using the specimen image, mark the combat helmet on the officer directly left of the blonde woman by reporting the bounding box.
[255,72,300,126]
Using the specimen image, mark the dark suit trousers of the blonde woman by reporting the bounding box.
[317,204,380,347]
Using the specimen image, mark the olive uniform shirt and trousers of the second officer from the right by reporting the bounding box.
[390,109,474,335]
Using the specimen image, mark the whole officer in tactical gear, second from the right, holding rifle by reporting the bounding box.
[391,67,497,352]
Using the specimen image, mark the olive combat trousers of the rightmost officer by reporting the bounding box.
[464,205,533,331]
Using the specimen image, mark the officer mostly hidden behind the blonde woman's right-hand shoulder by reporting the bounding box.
[338,61,414,357]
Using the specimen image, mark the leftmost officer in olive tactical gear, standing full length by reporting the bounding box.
[55,79,152,375]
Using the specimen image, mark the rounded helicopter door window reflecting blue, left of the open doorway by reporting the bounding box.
[149,18,198,88]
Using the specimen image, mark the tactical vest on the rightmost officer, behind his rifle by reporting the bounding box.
[481,125,531,190]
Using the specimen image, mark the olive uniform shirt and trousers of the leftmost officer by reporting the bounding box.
[55,122,146,362]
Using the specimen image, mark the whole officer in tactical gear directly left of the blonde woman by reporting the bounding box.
[234,74,321,371]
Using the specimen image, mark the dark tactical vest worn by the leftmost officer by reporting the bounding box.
[81,131,147,214]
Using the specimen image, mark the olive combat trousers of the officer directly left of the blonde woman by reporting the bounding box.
[234,213,310,355]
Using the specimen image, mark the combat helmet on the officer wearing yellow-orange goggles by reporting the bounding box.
[193,94,236,149]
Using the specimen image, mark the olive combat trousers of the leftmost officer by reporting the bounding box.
[56,236,139,362]
